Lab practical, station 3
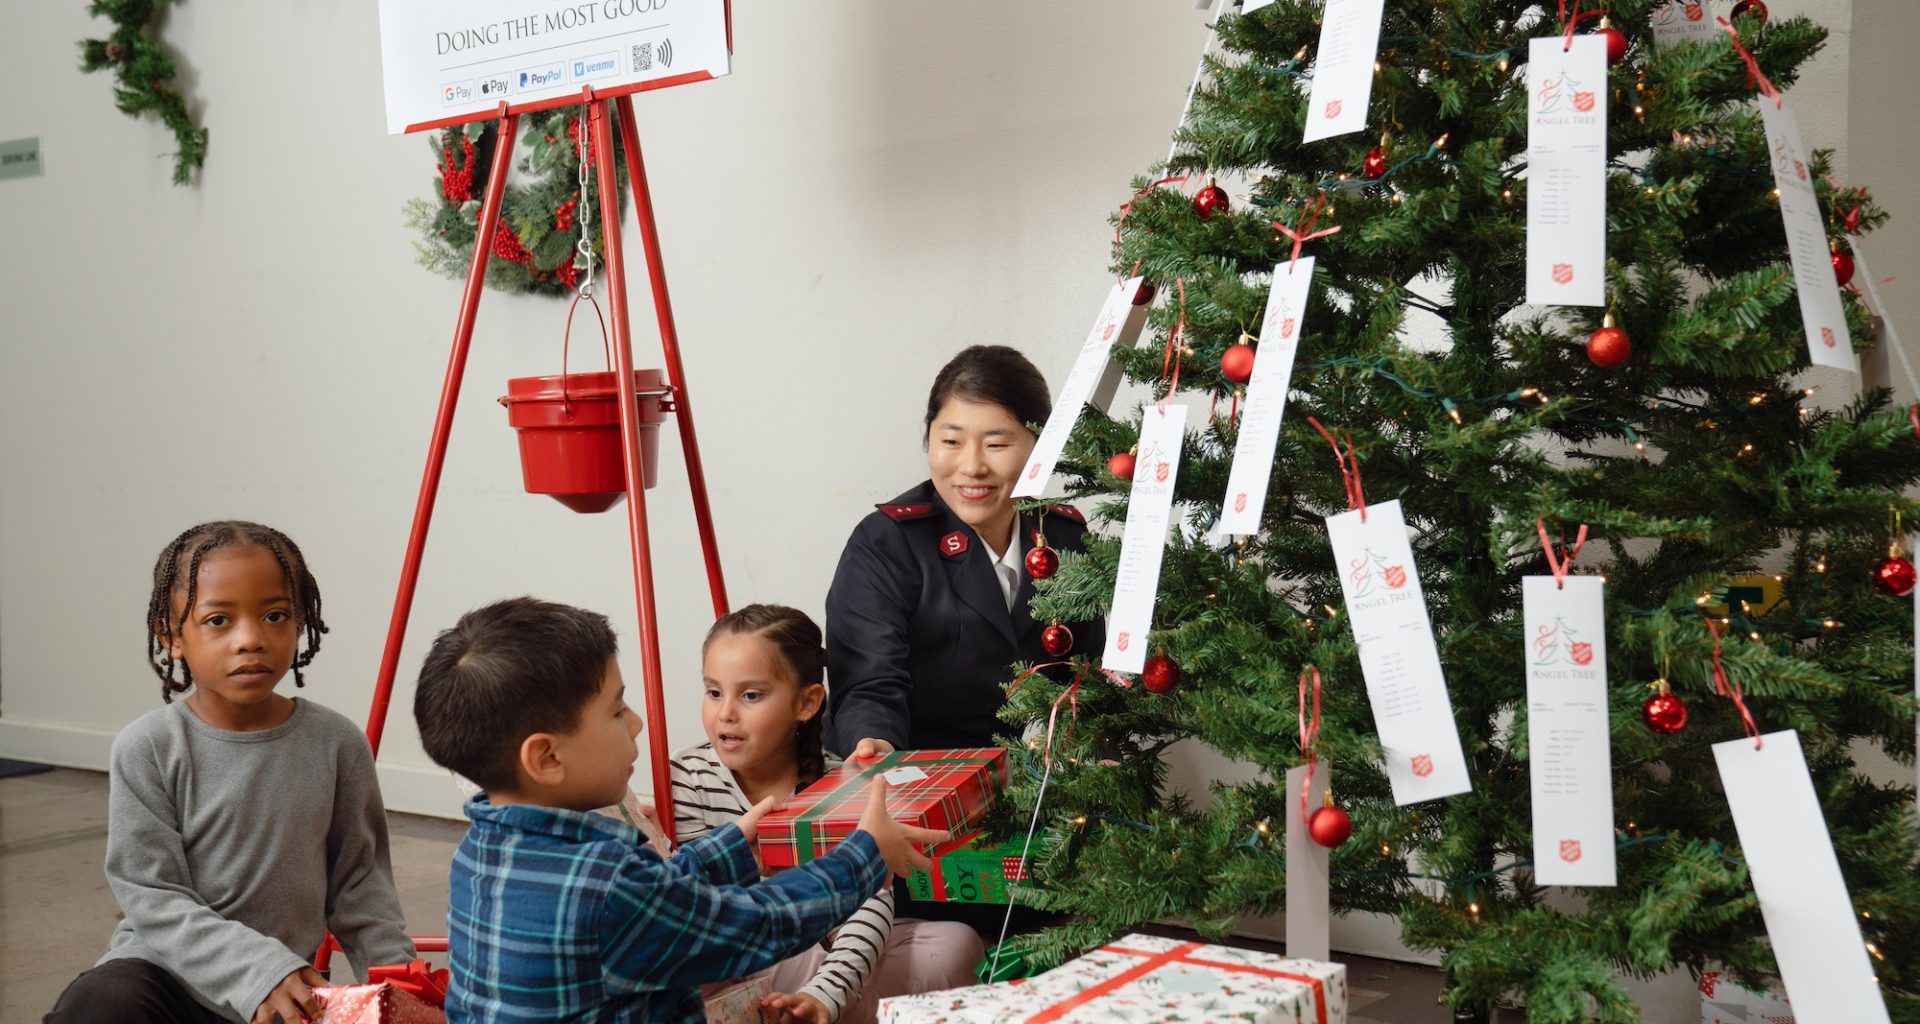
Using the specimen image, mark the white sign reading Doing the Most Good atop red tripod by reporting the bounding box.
[380,0,732,134]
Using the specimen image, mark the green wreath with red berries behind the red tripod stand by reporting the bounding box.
[405,108,626,296]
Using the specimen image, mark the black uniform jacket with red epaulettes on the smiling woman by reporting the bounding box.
[826,480,1106,757]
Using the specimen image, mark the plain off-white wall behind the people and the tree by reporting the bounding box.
[0,0,1920,1020]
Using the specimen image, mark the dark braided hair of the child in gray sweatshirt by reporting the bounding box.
[146,519,326,703]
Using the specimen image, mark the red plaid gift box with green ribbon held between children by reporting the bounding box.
[760,747,1006,868]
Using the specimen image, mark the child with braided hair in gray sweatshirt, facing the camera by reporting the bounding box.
[46,523,415,1024]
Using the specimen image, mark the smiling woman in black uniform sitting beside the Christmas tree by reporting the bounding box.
[826,346,1106,757]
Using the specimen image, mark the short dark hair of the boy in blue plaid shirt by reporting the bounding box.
[413,597,618,792]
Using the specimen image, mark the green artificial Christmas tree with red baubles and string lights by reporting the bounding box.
[1004,0,1920,1022]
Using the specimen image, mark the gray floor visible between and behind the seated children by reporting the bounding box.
[0,768,1519,1024]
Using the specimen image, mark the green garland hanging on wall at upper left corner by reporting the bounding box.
[81,0,207,184]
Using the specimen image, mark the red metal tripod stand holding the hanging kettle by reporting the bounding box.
[315,88,728,970]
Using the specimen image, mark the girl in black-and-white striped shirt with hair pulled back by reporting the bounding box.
[672,605,981,1024]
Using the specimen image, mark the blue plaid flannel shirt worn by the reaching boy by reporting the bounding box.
[447,795,887,1024]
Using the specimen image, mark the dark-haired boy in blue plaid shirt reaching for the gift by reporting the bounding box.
[413,597,947,1024]
